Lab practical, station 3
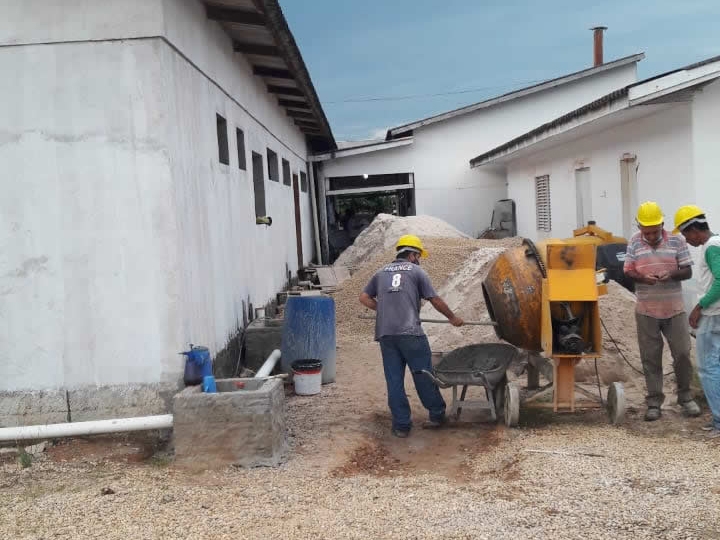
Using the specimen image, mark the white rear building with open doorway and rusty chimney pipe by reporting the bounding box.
[312,32,644,260]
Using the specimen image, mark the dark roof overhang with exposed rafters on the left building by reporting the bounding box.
[202,0,337,152]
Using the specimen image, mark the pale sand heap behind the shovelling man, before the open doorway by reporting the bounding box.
[335,214,469,268]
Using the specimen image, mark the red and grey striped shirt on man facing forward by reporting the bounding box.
[623,231,693,319]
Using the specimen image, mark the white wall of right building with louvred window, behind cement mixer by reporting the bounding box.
[507,103,694,239]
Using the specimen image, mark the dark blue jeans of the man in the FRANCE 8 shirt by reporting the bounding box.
[380,336,445,431]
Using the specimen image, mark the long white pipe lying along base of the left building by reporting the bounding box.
[0,414,173,442]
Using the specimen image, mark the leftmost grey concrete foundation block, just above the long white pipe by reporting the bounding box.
[0,390,67,427]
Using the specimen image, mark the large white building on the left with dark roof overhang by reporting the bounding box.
[0,0,336,425]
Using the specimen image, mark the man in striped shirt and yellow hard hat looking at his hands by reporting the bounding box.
[623,201,700,422]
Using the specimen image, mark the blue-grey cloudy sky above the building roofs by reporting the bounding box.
[280,0,720,141]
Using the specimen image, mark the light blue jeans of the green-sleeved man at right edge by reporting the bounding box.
[695,315,720,429]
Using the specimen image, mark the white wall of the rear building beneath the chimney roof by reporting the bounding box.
[324,64,636,235]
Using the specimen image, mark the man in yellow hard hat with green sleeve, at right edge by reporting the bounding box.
[673,204,720,437]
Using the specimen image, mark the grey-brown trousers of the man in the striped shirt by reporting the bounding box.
[635,313,693,407]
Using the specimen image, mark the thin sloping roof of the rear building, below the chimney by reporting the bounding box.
[386,53,645,140]
